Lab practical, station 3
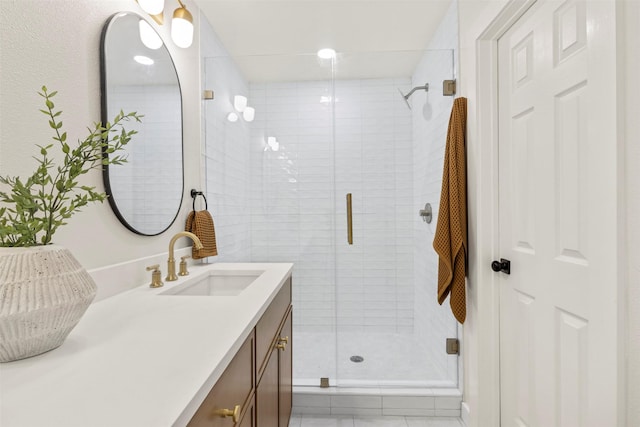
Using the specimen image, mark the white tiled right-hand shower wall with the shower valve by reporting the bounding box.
[411,3,458,382]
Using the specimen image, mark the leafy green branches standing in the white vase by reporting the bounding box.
[0,86,142,246]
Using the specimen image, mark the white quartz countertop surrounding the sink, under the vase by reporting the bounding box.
[0,263,293,427]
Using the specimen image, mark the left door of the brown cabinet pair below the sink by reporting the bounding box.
[256,347,279,427]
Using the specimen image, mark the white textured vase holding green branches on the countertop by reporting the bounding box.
[0,245,97,362]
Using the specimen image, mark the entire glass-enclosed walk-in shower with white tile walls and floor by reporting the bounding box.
[204,49,458,389]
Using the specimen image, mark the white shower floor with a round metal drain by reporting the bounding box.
[293,332,457,387]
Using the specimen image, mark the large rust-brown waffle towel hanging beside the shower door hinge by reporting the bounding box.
[433,98,467,323]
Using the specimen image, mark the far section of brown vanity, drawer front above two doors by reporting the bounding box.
[256,280,292,427]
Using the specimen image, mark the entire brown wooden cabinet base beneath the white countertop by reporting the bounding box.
[188,277,292,427]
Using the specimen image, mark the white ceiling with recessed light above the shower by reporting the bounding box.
[192,0,451,82]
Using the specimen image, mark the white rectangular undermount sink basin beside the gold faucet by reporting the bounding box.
[160,270,264,296]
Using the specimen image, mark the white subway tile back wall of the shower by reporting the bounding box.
[250,78,413,332]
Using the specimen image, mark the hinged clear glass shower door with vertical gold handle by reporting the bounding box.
[335,50,458,388]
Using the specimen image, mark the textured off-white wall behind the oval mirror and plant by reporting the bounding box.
[0,0,201,283]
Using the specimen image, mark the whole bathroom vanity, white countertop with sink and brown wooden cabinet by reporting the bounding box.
[0,263,293,427]
